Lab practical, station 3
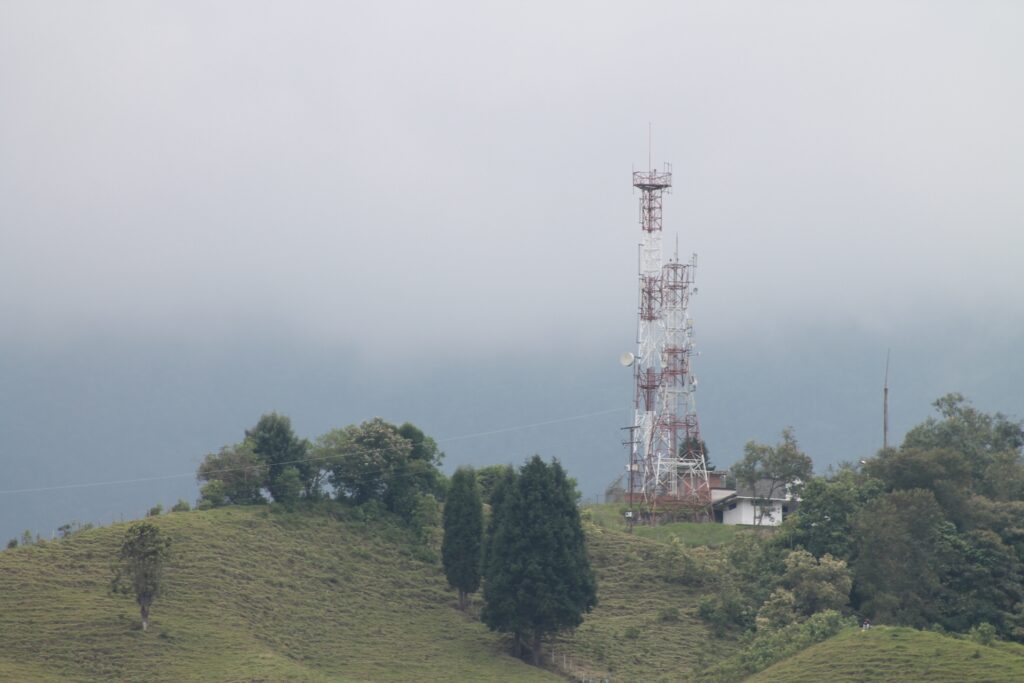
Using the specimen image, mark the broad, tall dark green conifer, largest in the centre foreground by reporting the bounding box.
[481,456,597,664]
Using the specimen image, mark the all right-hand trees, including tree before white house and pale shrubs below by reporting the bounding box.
[700,393,1024,642]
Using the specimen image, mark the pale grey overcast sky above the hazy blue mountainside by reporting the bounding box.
[0,1,1024,354]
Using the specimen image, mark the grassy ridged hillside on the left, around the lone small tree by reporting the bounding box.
[0,508,559,683]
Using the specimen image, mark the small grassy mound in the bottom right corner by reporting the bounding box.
[745,627,1024,683]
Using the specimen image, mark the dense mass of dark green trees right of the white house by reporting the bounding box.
[776,394,1024,640]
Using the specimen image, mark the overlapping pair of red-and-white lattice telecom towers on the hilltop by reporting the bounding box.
[627,164,711,519]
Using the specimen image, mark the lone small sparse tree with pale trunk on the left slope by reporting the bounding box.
[111,521,171,631]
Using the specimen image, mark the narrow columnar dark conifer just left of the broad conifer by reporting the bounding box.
[441,467,483,610]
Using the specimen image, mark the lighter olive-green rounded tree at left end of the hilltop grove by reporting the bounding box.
[196,439,266,507]
